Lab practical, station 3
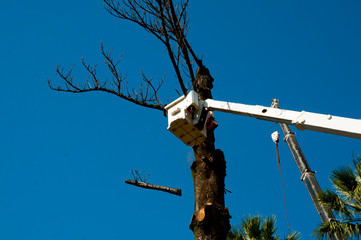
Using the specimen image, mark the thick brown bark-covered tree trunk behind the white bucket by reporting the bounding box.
[190,67,230,240]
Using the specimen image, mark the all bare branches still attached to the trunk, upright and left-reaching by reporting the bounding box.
[48,0,203,110]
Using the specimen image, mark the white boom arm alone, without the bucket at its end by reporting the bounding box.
[203,99,361,139]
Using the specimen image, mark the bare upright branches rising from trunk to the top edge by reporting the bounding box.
[104,0,203,94]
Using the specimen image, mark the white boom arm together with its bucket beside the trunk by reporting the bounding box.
[165,91,361,146]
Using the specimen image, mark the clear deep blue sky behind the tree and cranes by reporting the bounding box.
[0,0,361,240]
